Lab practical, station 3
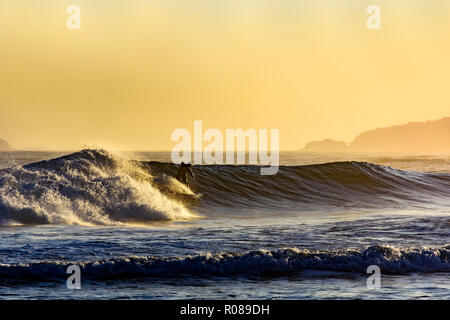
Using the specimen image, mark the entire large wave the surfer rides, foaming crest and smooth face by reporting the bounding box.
[0,150,450,225]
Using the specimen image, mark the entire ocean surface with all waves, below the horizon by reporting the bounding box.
[0,150,450,299]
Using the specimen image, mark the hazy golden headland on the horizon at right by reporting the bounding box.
[302,117,450,152]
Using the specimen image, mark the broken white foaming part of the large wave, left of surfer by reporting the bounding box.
[0,150,192,225]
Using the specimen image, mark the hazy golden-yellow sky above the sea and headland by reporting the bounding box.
[0,0,450,150]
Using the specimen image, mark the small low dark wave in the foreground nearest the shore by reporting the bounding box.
[0,246,450,280]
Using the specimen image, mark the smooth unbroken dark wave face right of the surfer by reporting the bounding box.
[146,162,450,210]
